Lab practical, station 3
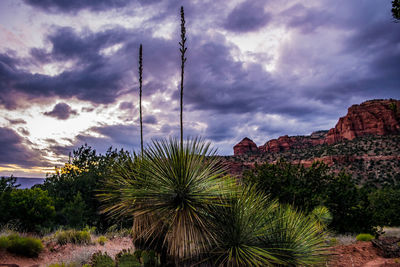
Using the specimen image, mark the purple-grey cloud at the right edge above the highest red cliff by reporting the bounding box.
[309,18,400,101]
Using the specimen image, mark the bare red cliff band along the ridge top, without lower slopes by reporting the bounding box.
[233,99,400,156]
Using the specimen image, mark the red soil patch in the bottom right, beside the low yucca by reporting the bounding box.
[327,242,400,267]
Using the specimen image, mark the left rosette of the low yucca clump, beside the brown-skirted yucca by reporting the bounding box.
[203,187,282,266]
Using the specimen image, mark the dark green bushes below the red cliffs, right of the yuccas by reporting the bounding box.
[243,159,376,233]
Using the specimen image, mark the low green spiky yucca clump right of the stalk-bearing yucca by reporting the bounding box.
[203,186,326,266]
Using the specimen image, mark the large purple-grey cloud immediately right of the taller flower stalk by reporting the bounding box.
[181,38,313,118]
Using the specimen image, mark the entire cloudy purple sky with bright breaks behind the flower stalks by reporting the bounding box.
[0,0,400,177]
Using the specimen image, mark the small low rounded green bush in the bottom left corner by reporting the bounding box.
[0,234,43,258]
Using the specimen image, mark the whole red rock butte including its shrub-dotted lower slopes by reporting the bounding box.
[224,99,400,185]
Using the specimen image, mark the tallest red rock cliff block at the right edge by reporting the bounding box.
[326,100,400,144]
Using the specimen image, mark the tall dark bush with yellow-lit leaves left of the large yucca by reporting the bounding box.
[41,145,132,231]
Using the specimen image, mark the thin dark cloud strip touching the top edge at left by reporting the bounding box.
[24,0,133,13]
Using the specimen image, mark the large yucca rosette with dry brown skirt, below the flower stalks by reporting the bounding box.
[99,138,235,261]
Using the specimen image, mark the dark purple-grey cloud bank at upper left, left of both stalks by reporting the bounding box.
[0,28,134,109]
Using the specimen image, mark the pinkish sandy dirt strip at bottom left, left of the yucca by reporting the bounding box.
[0,237,133,267]
